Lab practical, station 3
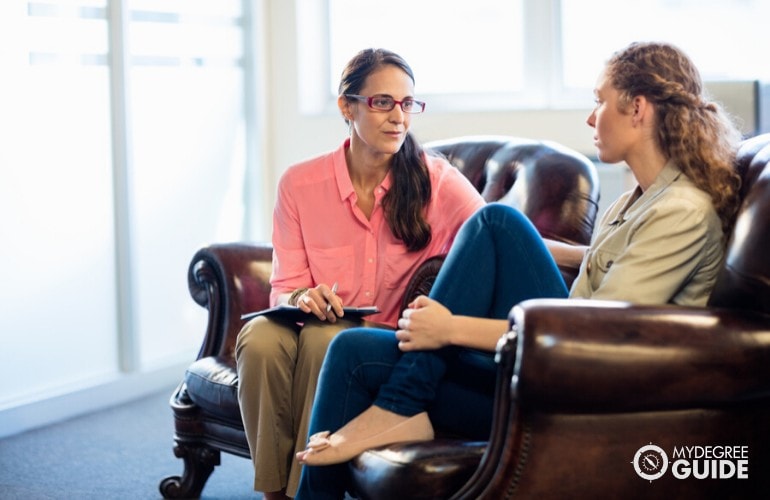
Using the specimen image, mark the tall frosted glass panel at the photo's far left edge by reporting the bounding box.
[0,0,118,398]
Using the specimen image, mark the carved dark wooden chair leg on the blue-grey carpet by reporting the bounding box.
[159,445,220,498]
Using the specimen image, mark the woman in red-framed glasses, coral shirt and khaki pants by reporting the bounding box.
[236,49,484,500]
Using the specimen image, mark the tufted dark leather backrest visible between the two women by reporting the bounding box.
[425,136,599,245]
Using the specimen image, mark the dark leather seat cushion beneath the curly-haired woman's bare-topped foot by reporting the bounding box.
[350,439,487,499]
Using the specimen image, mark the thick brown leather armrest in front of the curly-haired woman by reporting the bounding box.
[503,299,770,413]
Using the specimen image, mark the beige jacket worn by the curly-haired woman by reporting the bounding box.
[570,161,724,306]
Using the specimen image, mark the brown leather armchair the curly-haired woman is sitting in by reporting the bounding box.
[350,134,770,500]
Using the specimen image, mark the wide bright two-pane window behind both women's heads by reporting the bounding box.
[306,0,770,111]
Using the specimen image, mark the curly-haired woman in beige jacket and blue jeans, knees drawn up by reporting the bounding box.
[297,43,740,499]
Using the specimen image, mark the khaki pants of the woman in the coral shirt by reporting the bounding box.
[235,317,357,497]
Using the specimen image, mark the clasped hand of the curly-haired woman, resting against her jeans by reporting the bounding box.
[396,295,452,351]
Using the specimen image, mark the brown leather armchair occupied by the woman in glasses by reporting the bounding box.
[160,136,599,498]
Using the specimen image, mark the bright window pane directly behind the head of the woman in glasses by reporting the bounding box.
[298,0,530,112]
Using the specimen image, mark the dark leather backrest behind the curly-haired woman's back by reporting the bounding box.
[709,134,770,313]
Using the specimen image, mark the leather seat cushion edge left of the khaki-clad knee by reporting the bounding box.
[184,356,241,424]
